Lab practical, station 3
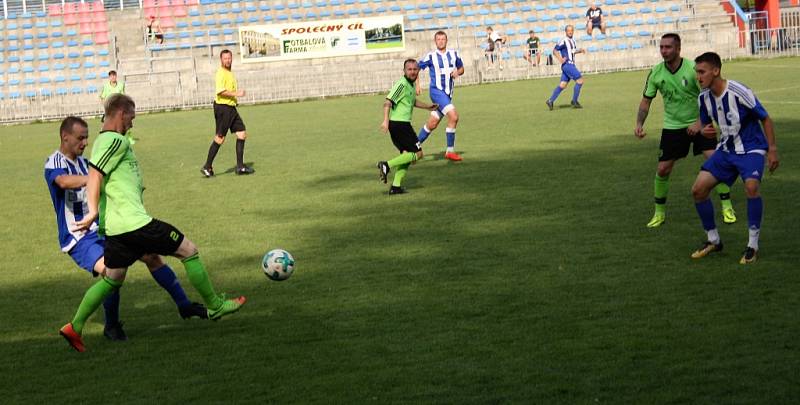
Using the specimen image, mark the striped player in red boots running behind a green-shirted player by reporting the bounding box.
[417,31,464,161]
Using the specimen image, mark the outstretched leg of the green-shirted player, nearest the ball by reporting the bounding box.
[164,219,247,320]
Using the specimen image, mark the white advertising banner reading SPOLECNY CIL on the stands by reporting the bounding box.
[239,15,405,63]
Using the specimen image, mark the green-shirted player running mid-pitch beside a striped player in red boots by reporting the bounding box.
[378,59,439,194]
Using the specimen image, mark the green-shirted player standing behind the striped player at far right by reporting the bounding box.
[634,33,736,228]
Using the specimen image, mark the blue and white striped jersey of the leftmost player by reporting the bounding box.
[44,151,97,252]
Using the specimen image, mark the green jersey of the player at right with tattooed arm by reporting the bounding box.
[643,58,700,129]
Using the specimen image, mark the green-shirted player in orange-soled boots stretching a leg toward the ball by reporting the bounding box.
[60,94,246,352]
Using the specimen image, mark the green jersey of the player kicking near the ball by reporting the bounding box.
[89,131,153,235]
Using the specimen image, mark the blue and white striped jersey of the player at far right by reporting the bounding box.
[697,80,769,155]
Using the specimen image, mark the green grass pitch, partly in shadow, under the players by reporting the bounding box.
[0,59,800,403]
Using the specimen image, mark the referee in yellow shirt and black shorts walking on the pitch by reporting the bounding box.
[200,49,255,177]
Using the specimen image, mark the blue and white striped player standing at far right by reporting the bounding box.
[692,52,778,264]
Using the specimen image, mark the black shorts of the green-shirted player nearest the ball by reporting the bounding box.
[105,219,183,269]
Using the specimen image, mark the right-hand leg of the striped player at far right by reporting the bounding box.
[734,153,764,264]
